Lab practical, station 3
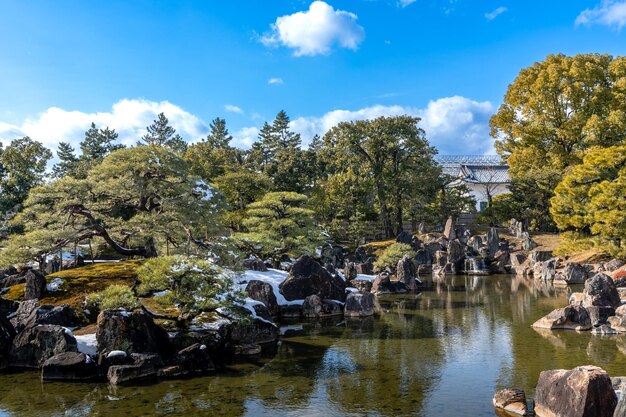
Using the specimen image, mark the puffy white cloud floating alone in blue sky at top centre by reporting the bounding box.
[261,1,365,56]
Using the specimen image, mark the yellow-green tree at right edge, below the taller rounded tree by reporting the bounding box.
[550,145,626,257]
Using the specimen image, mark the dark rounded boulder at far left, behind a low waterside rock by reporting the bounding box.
[9,324,78,369]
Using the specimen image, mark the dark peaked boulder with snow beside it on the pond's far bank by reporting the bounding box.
[280,255,346,301]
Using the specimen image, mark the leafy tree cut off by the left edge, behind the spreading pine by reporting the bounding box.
[0,136,52,212]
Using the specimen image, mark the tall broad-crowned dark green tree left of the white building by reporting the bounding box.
[322,116,440,237]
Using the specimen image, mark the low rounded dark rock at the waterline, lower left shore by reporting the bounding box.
[41,352,98,381]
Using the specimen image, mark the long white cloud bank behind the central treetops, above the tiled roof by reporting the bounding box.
[291,96,494,155]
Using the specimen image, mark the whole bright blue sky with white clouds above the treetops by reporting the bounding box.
[0,0,626,154]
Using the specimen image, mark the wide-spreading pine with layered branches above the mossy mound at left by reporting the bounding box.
[0,146,222,263]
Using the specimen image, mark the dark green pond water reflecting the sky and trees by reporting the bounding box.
[0,276,626,417]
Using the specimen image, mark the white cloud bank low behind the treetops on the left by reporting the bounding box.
[0,99,208,154]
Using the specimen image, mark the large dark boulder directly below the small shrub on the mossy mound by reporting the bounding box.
[96,310,171,357]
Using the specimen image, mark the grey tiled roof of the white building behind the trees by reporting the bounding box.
[435,155,510,184]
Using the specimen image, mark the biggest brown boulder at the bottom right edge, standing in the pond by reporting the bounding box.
[535,366,617,417]
